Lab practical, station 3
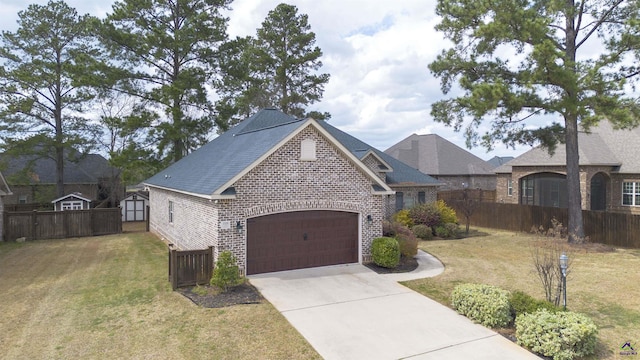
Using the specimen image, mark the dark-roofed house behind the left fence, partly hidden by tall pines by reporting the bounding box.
[0,154,124,207]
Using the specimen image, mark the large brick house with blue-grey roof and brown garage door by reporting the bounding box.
[145,109,438,274]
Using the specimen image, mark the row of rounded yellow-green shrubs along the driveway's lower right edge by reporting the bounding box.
[451,284,597,360]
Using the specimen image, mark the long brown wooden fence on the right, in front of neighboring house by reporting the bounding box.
[447,200,640,248]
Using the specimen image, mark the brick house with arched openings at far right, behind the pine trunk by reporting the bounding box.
[495,120,640,214]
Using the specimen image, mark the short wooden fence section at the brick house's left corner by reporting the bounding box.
[169,244,213,290]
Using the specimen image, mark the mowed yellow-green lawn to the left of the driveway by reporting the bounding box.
[0,232,320,359]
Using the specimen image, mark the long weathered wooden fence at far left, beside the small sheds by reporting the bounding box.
[3,208,122,241]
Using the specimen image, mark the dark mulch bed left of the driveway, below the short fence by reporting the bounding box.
[176,282,264,308]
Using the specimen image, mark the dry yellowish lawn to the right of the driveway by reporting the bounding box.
[405,229,640,359]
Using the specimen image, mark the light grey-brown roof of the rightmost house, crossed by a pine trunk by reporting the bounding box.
[495,120,640,174]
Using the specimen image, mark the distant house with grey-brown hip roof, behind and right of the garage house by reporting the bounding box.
[385,134,496,190]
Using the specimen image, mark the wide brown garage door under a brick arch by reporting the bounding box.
[247,211,358,275]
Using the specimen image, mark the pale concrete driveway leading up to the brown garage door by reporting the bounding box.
[249,255,539,359]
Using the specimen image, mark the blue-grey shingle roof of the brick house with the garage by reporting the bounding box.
[145,109,438,197]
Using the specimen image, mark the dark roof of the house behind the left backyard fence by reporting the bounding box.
[1,154,120,184]
